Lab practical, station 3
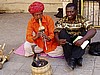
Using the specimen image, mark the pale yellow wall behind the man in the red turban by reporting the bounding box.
[0,0,70,13]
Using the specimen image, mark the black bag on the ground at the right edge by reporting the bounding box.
[88,42,100,56]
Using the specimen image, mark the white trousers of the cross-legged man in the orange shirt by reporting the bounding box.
[24,41,63,57]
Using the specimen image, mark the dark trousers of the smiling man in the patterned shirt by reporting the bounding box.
[59,29,86,61]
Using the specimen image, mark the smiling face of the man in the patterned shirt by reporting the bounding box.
[66,6,77,20]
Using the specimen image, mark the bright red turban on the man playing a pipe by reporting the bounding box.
[29,2,44,14]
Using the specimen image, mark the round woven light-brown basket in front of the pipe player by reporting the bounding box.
[31,59,52,75]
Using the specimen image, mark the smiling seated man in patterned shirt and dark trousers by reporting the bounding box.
[55,3,96,69]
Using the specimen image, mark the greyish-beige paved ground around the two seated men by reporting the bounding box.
[0,13,100,75]
